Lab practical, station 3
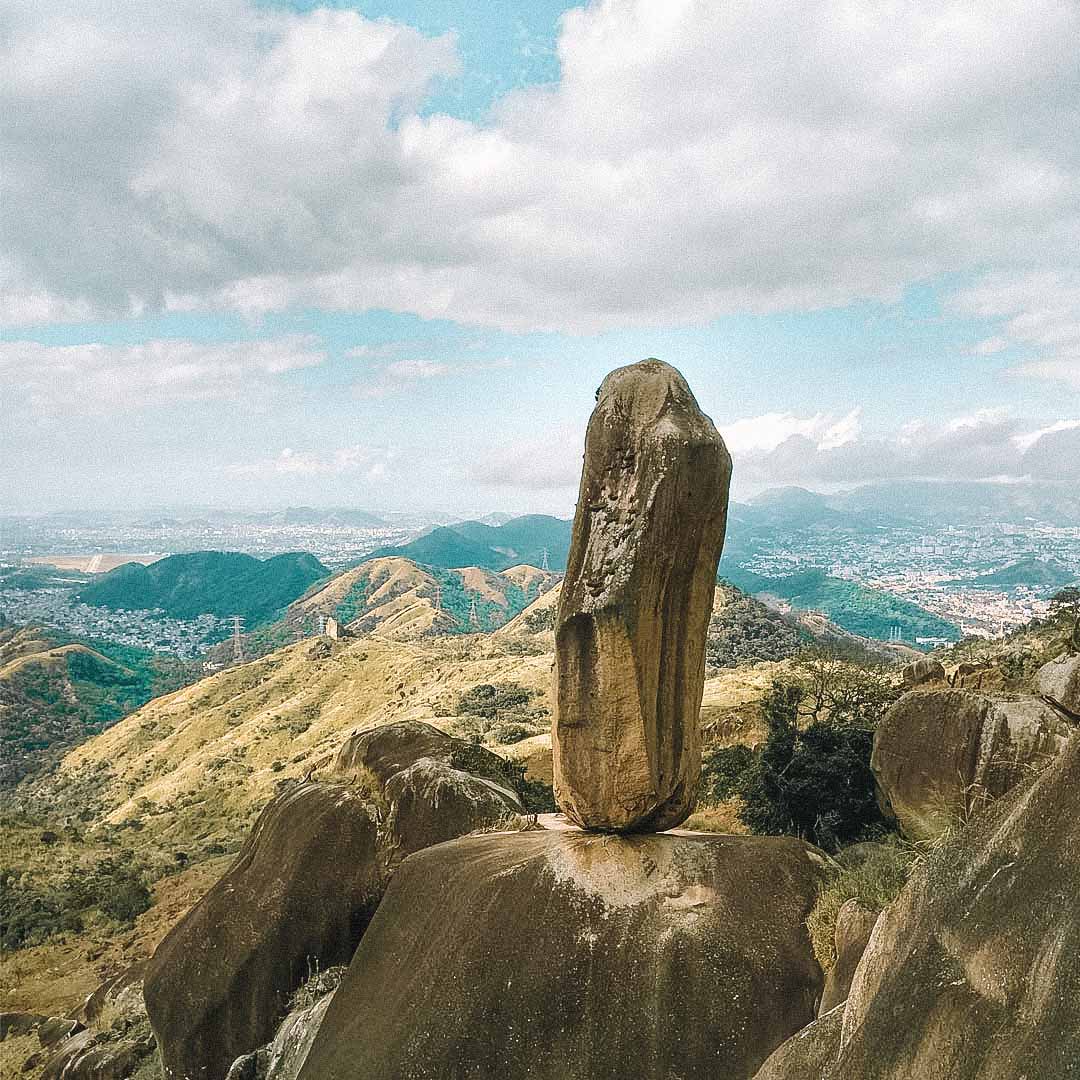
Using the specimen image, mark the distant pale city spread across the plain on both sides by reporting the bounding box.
[0,486,1080,659]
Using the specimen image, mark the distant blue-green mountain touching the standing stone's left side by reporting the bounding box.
[370,514,571,570]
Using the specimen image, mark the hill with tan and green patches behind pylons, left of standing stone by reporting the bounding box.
[285,555,557,639]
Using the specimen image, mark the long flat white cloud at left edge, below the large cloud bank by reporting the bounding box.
[0,336,326,416]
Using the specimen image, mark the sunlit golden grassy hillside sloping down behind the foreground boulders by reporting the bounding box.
[0,637,794,1011]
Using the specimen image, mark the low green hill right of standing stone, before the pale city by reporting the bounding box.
[723,566,960,642]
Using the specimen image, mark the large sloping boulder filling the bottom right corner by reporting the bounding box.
[833,737,1080,1080]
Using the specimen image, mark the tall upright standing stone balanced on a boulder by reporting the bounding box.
[552,360,731,833]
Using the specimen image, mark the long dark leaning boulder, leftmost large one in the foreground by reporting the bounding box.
[145,782,383,1080]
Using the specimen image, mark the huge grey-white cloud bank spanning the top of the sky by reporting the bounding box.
[6,0,1080,330]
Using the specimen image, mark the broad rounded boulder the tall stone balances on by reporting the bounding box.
[300,829,827,1080]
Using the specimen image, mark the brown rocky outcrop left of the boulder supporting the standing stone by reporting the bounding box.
[145,721,525,1080]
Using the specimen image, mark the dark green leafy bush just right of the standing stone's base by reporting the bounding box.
[742,681,886,851]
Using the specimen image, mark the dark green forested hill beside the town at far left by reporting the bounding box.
[77,551,329,626]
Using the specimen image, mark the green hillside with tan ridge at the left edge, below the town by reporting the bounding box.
[0,626,191,787]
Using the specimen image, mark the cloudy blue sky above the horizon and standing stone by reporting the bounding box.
[0,0,1080,513]
